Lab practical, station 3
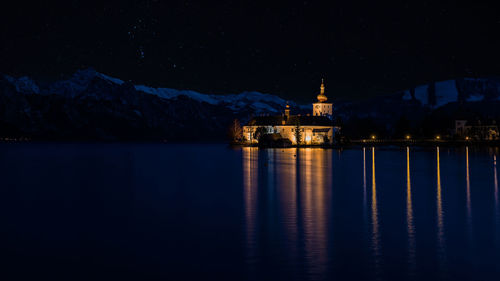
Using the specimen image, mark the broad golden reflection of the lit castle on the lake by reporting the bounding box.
[243,147,332,279]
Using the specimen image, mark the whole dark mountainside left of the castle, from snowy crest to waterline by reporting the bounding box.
[0,69,293,141]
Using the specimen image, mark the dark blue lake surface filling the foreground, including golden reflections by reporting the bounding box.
[0,144,500,280]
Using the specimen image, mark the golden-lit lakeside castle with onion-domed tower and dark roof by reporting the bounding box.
[243,79,340,145]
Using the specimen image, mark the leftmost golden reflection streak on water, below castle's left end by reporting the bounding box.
[243,147,259,262]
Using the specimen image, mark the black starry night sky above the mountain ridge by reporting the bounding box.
[0,0,500,101]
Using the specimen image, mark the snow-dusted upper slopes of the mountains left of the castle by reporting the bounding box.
[5,69,296,115]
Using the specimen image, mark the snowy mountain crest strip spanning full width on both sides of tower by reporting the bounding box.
[4,68,500,110]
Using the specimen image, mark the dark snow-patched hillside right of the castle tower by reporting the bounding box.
[335,78,500,138]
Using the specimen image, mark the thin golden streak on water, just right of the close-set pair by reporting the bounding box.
[406,147,416,274]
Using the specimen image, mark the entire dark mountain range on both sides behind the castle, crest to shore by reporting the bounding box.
[0,69,500,141]
